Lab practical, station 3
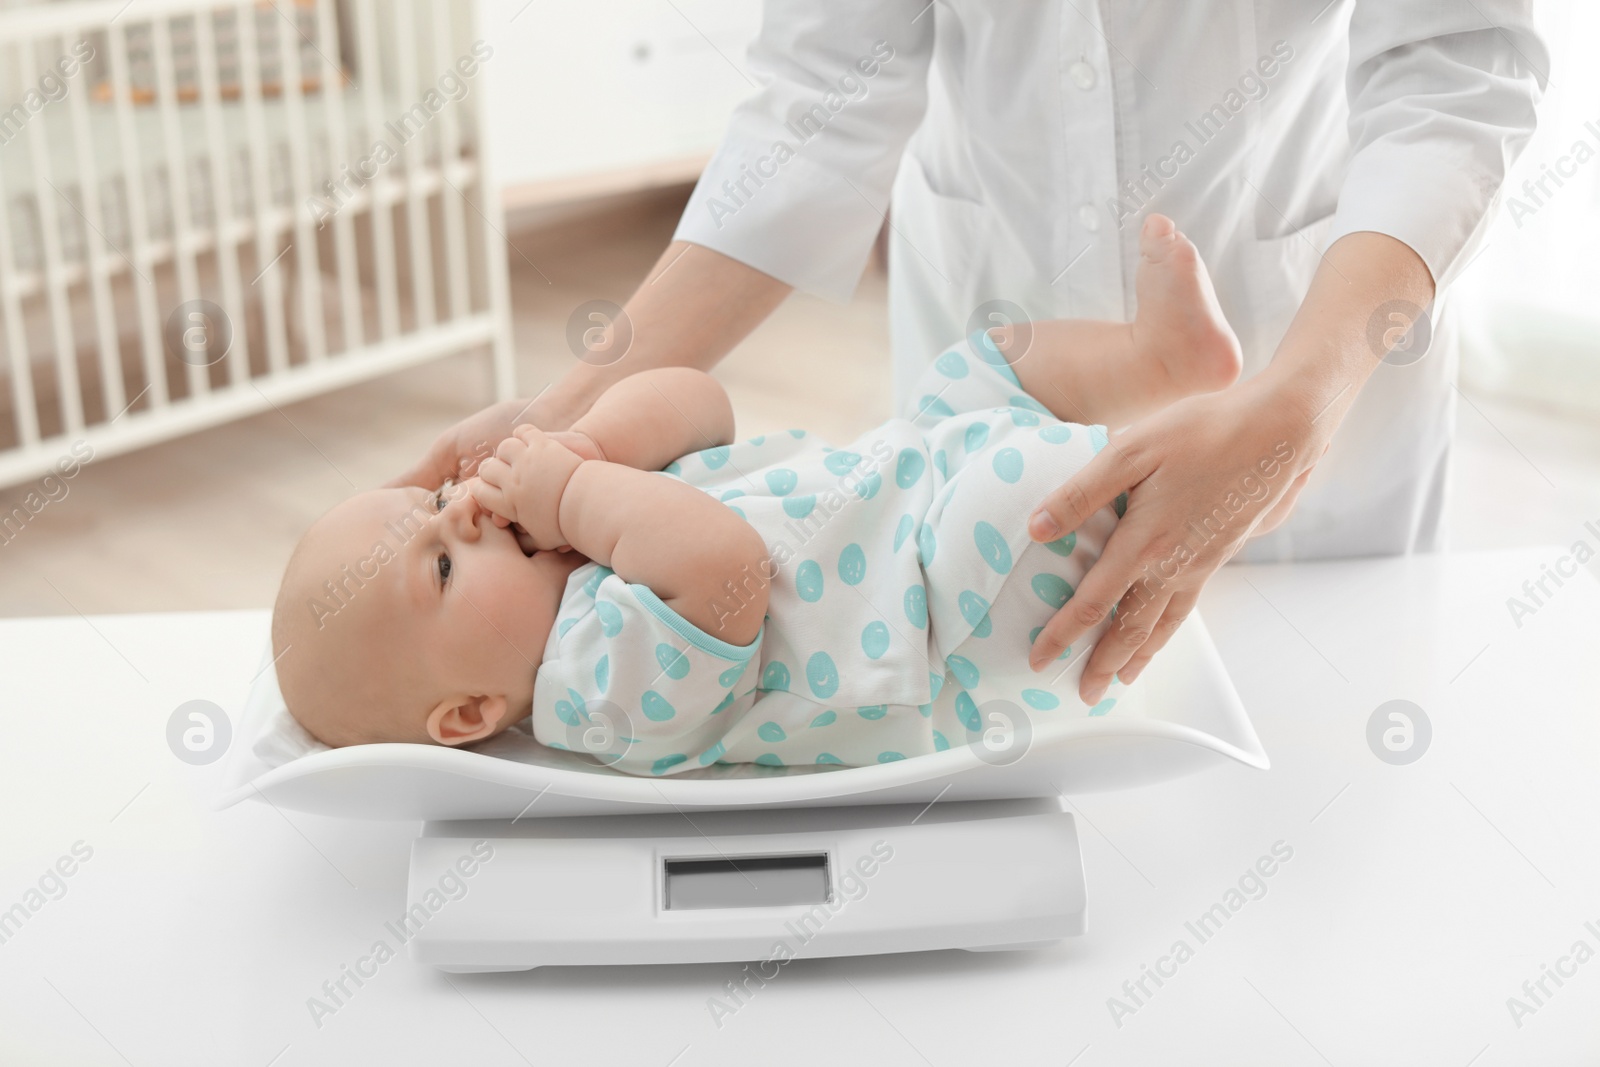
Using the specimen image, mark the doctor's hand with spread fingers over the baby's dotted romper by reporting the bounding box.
[1029,379,1331,704]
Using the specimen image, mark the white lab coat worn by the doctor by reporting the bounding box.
[677,0,1549,560]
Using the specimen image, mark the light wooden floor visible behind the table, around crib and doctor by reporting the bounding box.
[0,190,1600,616]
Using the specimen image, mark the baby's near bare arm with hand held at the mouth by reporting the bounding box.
[467,426,766,645]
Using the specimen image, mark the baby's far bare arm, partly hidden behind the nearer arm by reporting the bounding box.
[555,366,733,470]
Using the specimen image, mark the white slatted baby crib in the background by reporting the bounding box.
[0,0,515,486]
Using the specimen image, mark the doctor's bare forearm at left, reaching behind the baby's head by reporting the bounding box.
[542,242,790,422]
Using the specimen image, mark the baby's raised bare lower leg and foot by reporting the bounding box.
[990,214,1240,429]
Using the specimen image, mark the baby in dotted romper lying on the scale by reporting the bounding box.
[272,216,1240,774]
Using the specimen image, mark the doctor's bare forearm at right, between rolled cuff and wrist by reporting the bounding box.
[1259,232,1434,443]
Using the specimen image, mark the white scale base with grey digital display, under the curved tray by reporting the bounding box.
[397,798,1086,973]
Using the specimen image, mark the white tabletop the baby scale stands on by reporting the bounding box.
[0,549,1600,1067]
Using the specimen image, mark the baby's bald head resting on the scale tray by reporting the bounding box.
[272,488,584,747]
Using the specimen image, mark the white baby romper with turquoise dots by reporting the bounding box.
[531,333,1117,774]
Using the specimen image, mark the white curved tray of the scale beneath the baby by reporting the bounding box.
[219,614,1269,819]
